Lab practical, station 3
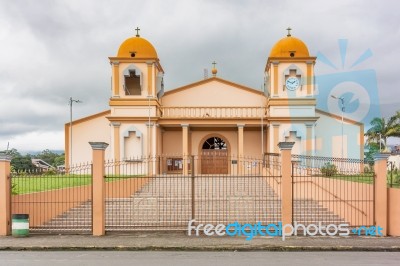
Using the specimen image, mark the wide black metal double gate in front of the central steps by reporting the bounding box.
[102,156,281,231]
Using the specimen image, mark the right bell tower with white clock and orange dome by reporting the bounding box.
[264,28,317,155]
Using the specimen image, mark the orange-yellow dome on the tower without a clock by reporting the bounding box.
[118,37,158,58]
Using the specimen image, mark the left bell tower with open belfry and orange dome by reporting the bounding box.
[107,28,164,167]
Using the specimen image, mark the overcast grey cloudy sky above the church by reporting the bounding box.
[0,0,400,151]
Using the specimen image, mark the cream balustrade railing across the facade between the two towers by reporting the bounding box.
[160,106,267,119]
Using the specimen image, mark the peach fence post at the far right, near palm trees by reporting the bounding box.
[374,153,390,236]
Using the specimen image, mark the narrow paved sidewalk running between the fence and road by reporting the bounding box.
[0,232,400,251]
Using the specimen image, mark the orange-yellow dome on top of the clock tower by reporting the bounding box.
[269,36,310,57]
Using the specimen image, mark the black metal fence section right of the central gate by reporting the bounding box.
[292,155,375,227]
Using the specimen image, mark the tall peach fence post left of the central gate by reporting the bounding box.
[89,142,108,236]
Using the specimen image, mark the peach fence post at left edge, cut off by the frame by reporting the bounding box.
[0,152,11,236]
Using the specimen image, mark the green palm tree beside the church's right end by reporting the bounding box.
[364,111,400,148]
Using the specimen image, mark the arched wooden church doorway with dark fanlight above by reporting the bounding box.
[201,136,228,174]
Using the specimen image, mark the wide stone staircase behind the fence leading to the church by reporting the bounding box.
[36,176,345,231]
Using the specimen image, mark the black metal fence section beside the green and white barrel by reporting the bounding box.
[11,164,92,233]
